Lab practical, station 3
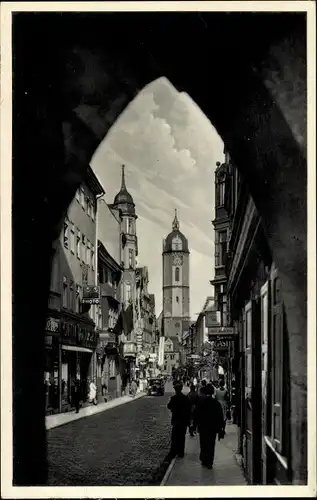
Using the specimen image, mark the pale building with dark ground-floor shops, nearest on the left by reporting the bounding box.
[44,167,104,413]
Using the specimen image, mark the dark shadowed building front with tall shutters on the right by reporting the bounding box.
[221,152,293,484]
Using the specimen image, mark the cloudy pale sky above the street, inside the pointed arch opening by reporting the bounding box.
[91,78,224,319]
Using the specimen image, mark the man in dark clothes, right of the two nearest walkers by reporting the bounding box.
[196,384,224,469]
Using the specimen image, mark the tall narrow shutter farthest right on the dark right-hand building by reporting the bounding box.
[271,269,283,453]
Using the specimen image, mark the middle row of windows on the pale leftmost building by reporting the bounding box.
[63,220,95,270]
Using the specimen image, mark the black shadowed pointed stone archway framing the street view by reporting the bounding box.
[13,14,307,485]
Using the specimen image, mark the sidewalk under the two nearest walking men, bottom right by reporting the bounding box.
[161,423,247,486]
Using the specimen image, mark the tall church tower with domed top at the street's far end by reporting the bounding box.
[162,210,190,340]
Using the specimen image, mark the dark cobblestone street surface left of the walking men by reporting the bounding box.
[47,393,170,486]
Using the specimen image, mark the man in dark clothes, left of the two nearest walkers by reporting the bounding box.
[167,383,191,458]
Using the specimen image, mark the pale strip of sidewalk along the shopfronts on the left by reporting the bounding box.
[45,392,145,430]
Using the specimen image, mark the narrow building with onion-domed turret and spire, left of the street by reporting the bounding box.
[110,165,138,380]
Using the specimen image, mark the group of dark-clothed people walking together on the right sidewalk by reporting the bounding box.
[167,379,227,469]
